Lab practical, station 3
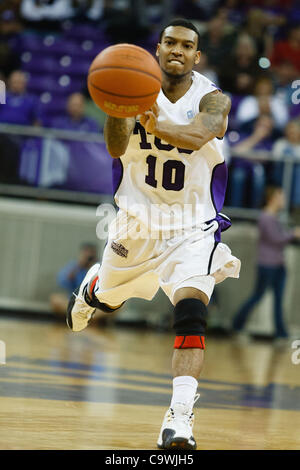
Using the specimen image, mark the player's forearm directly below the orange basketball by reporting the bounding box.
[104,116,135,158]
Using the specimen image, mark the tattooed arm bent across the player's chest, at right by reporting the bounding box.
[140,90,231,150]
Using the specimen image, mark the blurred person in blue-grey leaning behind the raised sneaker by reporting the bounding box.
[50,243,97,314]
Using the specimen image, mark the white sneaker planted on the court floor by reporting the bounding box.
[157,394,200,450]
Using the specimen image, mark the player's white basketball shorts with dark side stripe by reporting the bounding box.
[94,210,241,307]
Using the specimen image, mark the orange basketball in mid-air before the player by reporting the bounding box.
[88,44,162,118]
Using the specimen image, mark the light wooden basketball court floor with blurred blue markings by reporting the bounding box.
[0,316,300,450]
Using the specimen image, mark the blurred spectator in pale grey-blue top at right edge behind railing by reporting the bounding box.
[273,119,300,208]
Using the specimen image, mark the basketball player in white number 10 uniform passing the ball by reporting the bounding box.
[67,20,240,449]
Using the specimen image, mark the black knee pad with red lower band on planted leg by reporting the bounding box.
[173,298,207,349]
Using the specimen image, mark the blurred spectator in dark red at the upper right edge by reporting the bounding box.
[271,24,300,74]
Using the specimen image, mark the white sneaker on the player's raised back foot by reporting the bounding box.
[67,263,100,331]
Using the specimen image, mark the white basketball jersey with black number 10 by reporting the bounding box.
[113,72,230,237]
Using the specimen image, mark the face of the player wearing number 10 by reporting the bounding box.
[156,26,201,78]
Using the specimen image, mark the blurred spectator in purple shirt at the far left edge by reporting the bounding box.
[0,70,38,184]
